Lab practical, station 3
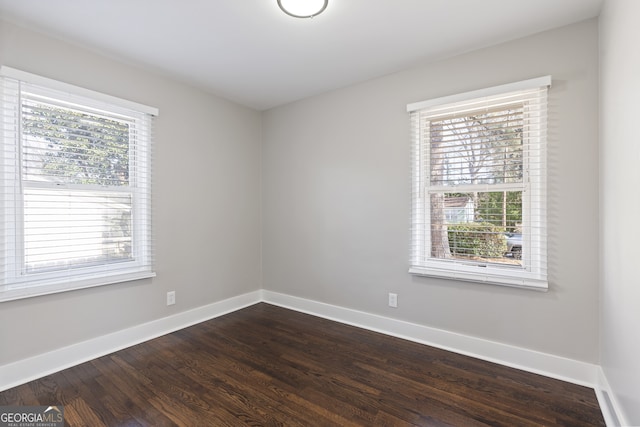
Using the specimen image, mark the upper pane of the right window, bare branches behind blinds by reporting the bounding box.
[428,105,523,185]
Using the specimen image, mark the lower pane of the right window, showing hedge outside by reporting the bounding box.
[430,191,522,265]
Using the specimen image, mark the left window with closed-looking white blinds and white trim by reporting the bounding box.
[0,67,157,301]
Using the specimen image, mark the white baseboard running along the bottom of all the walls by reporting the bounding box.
[0,290,626,426]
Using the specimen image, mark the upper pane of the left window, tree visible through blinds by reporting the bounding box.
[22,97,129,186]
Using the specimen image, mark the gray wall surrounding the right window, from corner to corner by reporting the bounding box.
[262,20,600,363]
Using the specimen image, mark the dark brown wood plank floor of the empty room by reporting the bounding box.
[0,303,604,427]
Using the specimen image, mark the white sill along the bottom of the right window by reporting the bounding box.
[409,267,549,292]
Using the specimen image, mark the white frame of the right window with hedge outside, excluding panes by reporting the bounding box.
[407,76,551,291]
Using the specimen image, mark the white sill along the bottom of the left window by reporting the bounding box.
[0,271,156,303]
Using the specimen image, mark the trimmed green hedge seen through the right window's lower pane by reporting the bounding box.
[448,222,507,258]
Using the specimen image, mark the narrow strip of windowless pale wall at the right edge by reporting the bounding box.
[600,0,640,425]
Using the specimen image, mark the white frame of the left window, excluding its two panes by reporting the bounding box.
[0,66,158,302]
